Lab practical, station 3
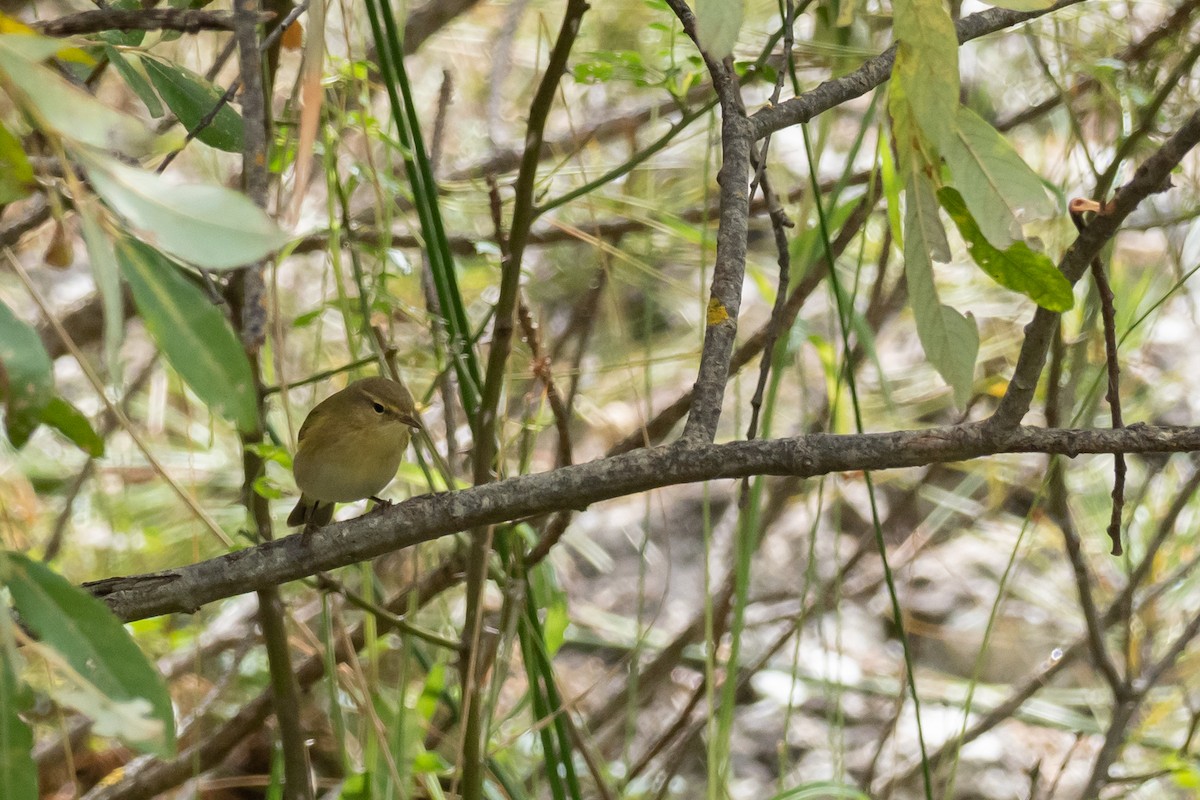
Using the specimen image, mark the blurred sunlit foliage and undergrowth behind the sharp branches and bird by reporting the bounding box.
[0,0,1200,800]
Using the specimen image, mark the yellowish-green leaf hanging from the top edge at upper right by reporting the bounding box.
[889,0,959,161]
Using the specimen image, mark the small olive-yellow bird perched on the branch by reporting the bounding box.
[288,378,421,534]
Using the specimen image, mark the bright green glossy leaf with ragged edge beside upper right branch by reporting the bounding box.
[937,186,1075,312]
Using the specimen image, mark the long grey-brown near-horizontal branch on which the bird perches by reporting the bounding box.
[89,423,1200,621]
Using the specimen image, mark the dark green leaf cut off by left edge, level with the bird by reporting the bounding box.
[0,302,54,447]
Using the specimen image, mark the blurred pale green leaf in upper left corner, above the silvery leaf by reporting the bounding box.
[0,35,157,156]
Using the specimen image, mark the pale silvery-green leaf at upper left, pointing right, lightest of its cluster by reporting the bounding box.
[77,149,288,270]
